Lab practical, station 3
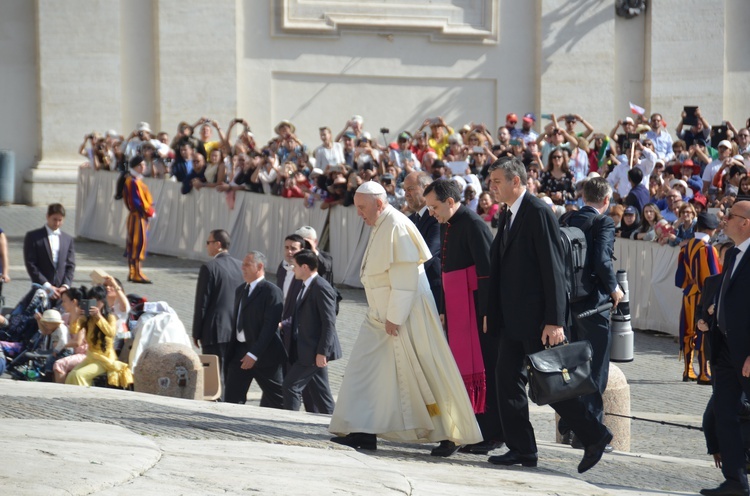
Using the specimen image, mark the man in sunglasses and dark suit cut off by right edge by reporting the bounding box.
[701,201,750,496]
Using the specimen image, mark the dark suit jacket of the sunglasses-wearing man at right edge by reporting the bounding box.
[714,248,750,371]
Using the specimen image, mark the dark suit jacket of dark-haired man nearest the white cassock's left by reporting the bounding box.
[292,276,341,366]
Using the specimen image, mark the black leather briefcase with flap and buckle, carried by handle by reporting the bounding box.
[525,340,597,405]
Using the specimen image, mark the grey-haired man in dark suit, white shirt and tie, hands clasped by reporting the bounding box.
[224,251,286,408]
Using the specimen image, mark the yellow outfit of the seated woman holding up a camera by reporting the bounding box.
[65,314,133,388]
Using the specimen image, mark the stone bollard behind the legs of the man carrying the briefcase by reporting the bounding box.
[555,363,630,451]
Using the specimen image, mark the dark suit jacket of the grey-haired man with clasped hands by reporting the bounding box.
[232,279,286,367]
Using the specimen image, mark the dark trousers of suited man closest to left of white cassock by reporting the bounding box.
[282,362,335,415]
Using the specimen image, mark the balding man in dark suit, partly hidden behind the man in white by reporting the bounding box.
[404,172,443,308]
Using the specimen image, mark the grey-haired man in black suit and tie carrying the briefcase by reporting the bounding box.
[487,157,612,473]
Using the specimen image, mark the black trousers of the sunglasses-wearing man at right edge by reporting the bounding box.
[711,330,750,490]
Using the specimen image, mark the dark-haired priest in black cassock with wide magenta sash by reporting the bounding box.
[424,179,504,456]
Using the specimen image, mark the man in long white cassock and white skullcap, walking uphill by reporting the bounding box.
[328,181,482,450]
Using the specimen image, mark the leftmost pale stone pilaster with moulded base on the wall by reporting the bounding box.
[23,0,122,206]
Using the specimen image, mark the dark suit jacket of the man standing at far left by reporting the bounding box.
[23,227,76,287]
